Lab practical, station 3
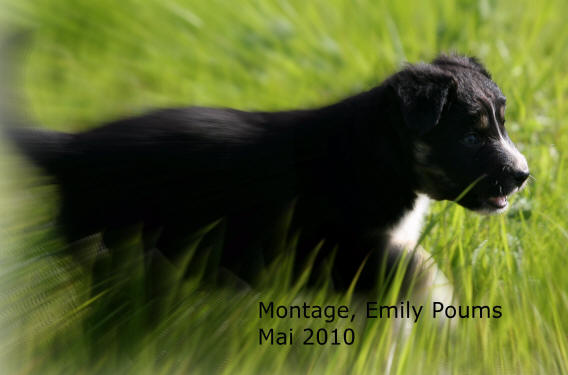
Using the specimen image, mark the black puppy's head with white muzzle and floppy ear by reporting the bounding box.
[388,56,529,213]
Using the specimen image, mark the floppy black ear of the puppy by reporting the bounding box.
[389,64,457,136]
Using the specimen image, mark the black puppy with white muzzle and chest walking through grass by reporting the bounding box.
[5,56,529,288]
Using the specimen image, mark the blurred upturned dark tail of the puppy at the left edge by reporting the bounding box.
[0,31,73,176]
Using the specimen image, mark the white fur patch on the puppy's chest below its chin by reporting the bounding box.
[389,194,430,250]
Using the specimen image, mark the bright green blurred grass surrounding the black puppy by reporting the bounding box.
[0,0,568,374]
